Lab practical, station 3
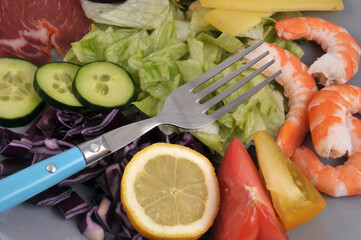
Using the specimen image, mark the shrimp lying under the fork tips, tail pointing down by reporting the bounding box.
[244,43,317,157]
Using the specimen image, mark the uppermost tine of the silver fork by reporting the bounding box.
[183,41,263,91]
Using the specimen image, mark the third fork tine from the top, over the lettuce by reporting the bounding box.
[202,59,275,111]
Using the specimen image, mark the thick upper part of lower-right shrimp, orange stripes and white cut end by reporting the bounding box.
[308,85,361,158]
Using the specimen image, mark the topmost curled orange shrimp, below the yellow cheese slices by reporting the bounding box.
[275,17,361,86]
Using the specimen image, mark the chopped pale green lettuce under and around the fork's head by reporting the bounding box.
[64,1,303,154]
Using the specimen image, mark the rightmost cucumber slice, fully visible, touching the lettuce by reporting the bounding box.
[73,61,137,111]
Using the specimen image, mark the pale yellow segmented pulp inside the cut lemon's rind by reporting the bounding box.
[135,155,208,226]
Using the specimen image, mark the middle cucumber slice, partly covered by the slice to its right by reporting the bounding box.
[34,62,83,111]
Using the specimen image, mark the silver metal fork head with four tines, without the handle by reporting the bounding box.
[158,42,281,129]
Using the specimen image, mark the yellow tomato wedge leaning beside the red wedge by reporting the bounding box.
[254,131,326,231]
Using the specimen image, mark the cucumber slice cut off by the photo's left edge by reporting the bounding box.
[0,58,45,127]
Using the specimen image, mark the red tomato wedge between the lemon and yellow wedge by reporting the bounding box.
[212,138,288,240]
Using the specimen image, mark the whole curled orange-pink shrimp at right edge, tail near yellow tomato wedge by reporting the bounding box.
[291,85,361,197]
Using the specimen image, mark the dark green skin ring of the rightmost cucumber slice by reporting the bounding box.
[72,61,138,112]
